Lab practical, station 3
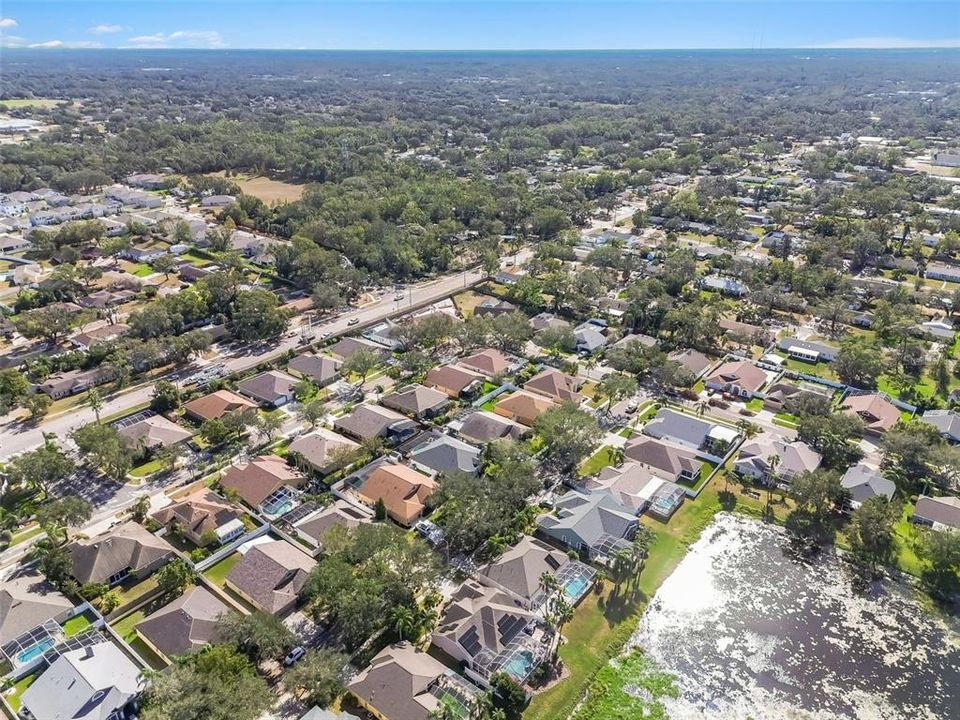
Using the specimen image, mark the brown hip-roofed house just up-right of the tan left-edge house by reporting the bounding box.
[67,520,175,585]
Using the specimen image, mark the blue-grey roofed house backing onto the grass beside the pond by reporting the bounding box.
[537,491,637,561]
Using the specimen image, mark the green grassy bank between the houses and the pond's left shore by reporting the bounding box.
[523,473,789,720]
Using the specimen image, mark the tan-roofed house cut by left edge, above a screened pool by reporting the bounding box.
[0,569,73,652]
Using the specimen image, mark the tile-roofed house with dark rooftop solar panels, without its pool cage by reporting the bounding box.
[431,580,536,682]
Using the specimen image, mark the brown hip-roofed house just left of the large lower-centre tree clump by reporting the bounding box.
[226,540,316,615]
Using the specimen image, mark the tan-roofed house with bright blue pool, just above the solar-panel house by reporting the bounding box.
[477,535,597,610]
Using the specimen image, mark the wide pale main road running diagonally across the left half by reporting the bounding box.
[0,250,532,460]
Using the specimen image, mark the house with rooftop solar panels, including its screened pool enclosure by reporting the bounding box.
[432,580,549,684]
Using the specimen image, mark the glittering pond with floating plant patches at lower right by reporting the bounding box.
[633,514,960,720]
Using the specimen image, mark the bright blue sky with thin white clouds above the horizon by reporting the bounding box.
[0,0,960,50]
